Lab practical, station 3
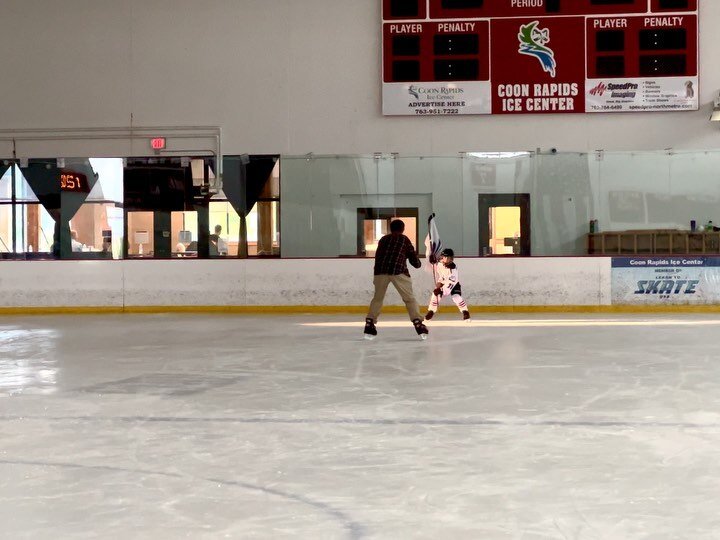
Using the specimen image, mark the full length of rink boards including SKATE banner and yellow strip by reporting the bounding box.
[0,257,720,313]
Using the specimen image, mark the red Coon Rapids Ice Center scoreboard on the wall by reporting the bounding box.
[382,0,699,116]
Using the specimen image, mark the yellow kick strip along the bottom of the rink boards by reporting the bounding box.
[0,304,720,316]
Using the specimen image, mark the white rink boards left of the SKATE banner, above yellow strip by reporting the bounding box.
[0,257,610,312]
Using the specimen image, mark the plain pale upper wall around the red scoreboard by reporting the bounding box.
[0,0,720,156]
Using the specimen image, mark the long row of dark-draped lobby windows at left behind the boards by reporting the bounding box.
[0,156,280,259]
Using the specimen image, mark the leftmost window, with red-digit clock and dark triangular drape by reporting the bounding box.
[0,158,122,259]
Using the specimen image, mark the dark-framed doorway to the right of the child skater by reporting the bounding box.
[478,193,531,257]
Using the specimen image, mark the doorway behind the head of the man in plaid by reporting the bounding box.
[357,208,419,257]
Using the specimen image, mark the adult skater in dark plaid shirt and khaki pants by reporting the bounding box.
[365,219,428,339]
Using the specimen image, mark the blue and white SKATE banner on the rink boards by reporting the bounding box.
[611,256,720,305]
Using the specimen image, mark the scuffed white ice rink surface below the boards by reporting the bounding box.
[0,308,720,540]
